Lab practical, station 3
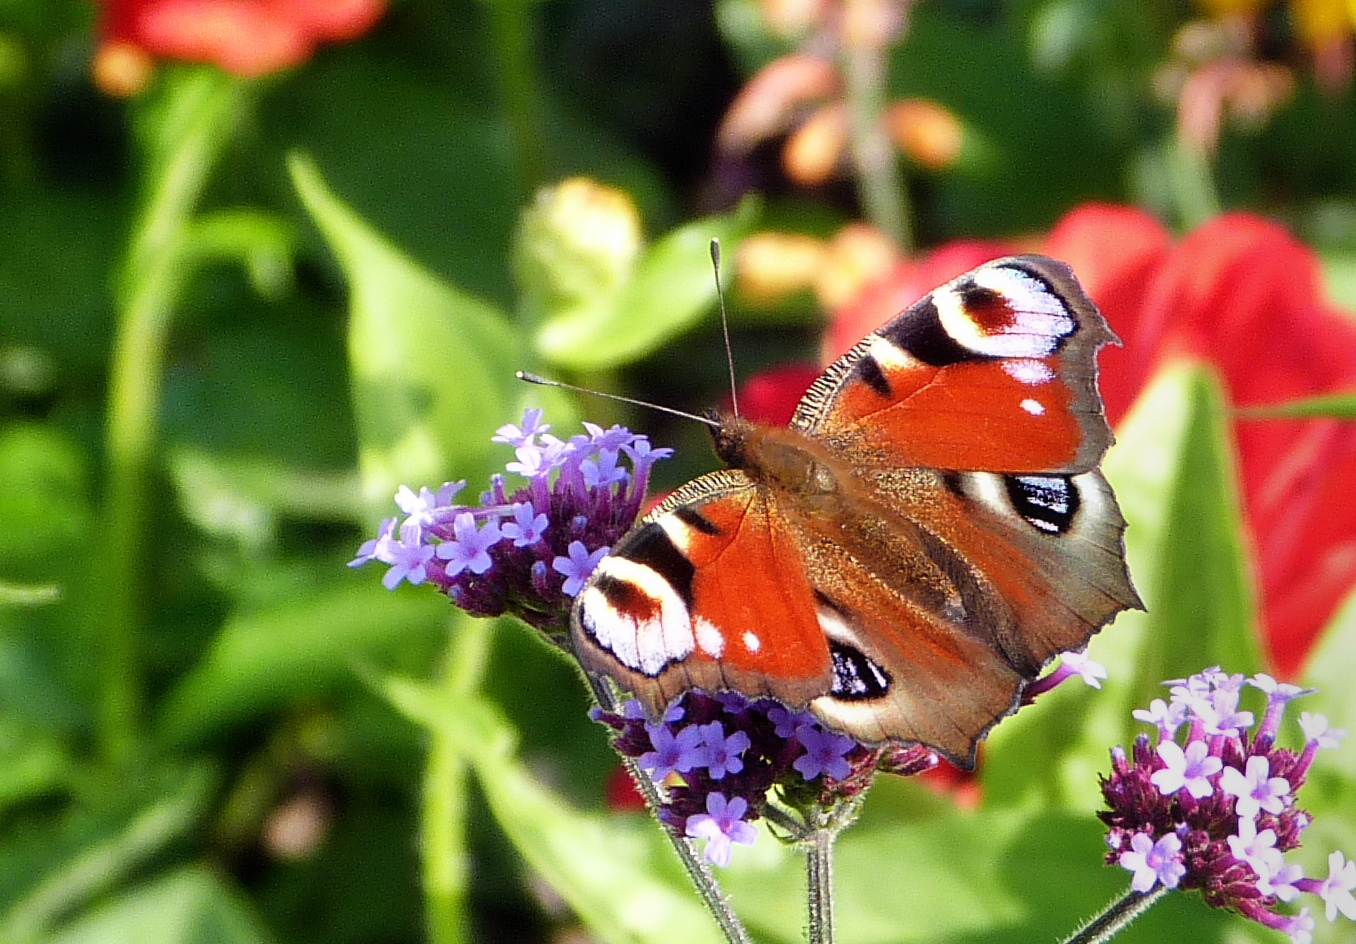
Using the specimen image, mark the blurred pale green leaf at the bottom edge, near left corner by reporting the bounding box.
[49,867,271,944]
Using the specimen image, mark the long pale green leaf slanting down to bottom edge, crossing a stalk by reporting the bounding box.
[382,678,721,944]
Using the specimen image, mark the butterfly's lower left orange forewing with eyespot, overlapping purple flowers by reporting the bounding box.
[572,471,831,712]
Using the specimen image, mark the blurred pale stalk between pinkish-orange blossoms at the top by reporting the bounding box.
[842,36,914,255]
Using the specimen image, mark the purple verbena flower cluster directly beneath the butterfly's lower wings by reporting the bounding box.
[594,690,938,865]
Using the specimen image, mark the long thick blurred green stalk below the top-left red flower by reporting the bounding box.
[99,69,247,765]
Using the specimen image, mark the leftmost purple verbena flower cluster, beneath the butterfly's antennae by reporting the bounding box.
[348,410,673,643]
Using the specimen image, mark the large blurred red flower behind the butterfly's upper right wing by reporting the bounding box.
[750,205,1356,677]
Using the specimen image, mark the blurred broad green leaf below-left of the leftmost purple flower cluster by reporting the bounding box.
[159,582,447,745]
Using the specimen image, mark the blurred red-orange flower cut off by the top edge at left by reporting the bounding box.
[95,0,386,83]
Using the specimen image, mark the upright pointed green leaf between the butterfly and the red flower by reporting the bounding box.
[983,366,1261,808]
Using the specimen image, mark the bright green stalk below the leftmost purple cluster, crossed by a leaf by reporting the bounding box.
[420,610,494,944]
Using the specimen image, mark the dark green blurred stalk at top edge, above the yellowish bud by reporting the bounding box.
[485,0,546,201]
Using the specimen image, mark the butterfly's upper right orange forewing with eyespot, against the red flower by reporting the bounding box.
[792,256,1115,472]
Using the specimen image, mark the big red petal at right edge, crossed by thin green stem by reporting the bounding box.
[1132,213,1356,675]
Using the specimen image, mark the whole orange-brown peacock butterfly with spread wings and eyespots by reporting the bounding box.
[571,255,1142,766]
